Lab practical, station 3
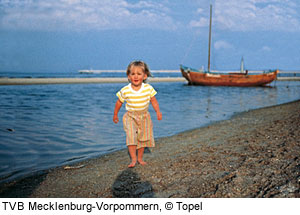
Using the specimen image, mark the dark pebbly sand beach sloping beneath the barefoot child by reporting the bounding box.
[0,100,300,198]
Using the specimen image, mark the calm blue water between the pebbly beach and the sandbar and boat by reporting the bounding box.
[0,77,300,182]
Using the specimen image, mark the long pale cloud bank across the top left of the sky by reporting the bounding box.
[0,0,176,31]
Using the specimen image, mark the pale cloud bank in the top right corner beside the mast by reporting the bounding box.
[190,0,300,32]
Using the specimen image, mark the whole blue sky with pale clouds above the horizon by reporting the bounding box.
[0,0,300,72]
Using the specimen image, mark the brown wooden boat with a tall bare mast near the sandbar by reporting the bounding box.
[180,5,278,87]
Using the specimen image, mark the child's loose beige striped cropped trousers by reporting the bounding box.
[123,110,155,149]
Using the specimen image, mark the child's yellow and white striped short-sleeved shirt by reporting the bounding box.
[117,83,157,111]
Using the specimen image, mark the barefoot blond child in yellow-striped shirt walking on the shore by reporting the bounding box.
[113,61,162,167]
